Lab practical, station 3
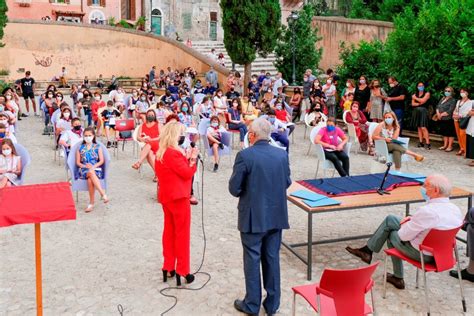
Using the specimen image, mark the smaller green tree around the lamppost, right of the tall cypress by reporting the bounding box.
[275,5,323,83]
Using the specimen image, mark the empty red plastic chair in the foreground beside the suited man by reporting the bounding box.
[292,262,379,316]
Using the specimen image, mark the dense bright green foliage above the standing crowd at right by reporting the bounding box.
[338,0,474,96]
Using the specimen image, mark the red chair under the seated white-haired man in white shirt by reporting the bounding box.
[383,226,467,315]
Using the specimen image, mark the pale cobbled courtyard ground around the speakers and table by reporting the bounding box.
[0,97,474,316]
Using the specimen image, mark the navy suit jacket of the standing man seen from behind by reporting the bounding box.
[229,141,291,233]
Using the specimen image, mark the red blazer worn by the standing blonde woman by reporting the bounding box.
[155,148,196,203]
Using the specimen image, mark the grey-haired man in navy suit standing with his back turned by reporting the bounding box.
[229,118,291,315]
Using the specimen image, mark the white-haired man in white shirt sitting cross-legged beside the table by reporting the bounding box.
[346,174,463,290]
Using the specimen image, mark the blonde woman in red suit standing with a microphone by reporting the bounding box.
[155,122,198,286]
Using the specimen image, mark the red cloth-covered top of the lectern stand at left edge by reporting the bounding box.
[0,182,76,227]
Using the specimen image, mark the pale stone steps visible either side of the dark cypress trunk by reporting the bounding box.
[193,41,277,75]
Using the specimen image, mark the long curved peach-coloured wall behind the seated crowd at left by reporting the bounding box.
[0,20,229,82]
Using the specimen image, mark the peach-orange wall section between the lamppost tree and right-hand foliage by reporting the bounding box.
[313,16,394,69]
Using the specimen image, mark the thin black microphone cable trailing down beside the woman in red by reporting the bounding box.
[160,157,211,316]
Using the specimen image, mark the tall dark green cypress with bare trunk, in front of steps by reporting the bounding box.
[220,0,281,89]
